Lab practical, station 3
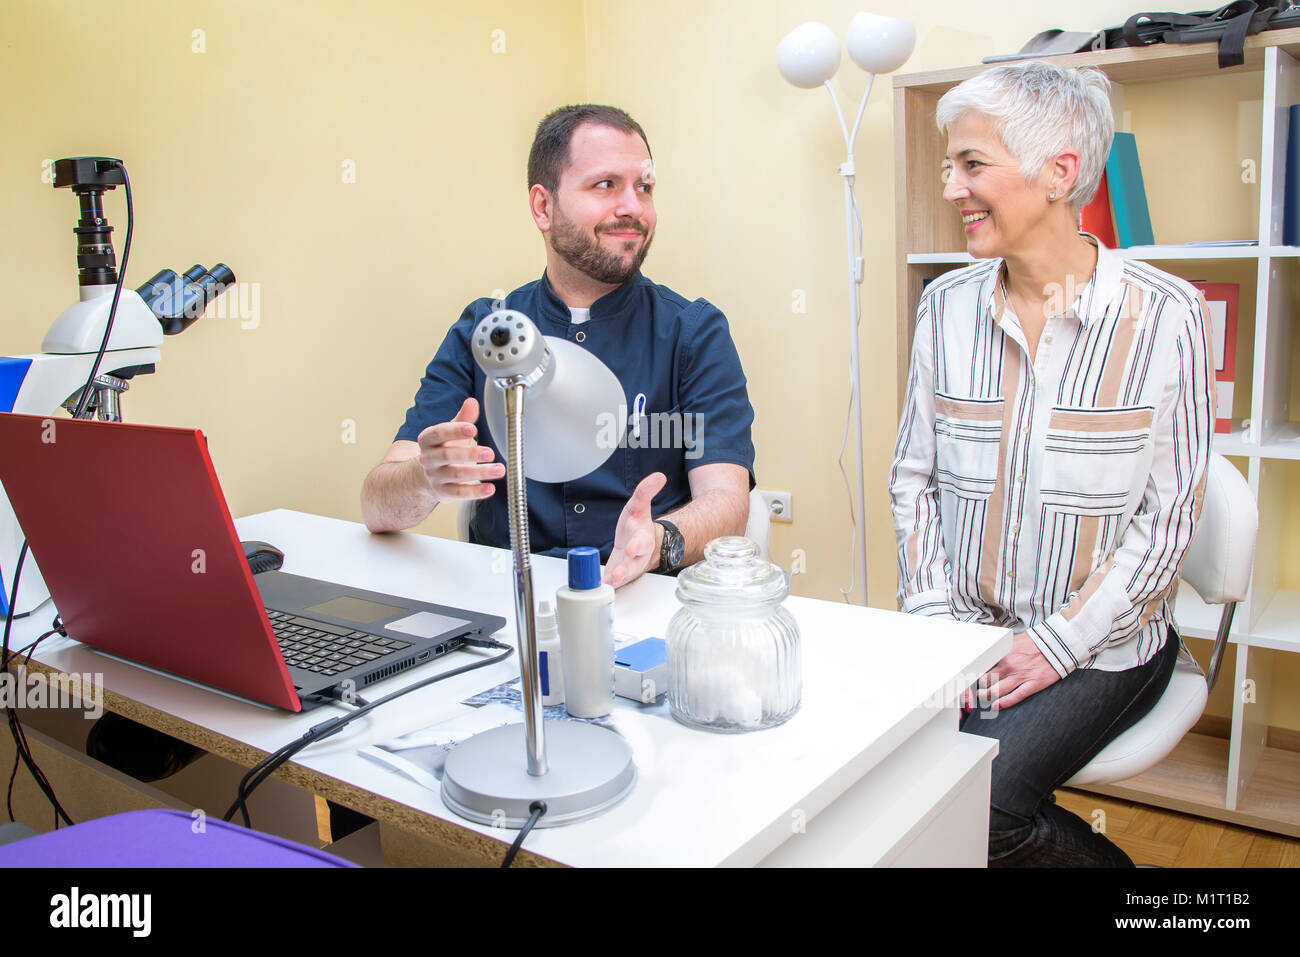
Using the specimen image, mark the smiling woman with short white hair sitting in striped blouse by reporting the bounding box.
[889,62,1214,866]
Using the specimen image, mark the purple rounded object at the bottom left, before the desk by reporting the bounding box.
[0,810,356,867]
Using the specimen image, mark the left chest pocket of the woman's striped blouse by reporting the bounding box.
[935,393,1004,498]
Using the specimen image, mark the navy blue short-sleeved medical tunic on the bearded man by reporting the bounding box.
[397,273,754,560]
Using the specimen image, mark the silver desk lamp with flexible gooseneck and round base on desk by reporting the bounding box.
[442,309,637,828]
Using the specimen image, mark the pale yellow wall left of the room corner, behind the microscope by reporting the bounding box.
[0,0,585,546]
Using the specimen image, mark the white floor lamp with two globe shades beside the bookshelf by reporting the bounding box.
[776,13,917,605]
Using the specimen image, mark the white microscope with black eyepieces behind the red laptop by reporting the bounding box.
[0,156,235,618]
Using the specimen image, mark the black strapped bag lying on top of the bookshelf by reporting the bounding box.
[1097,0,1300,69]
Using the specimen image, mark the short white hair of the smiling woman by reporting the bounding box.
[935,60,1115,209]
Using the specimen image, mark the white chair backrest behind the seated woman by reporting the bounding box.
[1182,452,1260,605]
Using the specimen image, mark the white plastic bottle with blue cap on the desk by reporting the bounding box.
[555,546,614,718]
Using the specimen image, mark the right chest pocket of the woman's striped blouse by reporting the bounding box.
[1043,406,1156,515]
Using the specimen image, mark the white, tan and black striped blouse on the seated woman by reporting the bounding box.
[889,237,1214,676]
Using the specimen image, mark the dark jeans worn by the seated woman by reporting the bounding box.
[961,631,1178,867]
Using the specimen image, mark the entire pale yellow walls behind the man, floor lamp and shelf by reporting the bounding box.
[0,0,1300,728]
